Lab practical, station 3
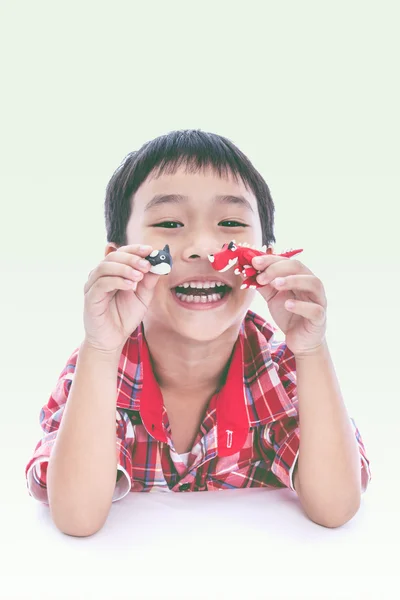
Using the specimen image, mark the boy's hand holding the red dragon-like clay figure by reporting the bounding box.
[252,255,327,356]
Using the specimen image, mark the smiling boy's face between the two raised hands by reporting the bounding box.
[122,166,262,341]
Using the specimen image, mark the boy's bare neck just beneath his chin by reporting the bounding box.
[145,326,240,398]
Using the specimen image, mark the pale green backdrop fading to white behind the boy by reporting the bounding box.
[0,0,400,598]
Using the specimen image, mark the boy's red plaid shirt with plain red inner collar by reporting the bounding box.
[25,311,371,504]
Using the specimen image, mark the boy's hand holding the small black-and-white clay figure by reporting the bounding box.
[83,244,160,353]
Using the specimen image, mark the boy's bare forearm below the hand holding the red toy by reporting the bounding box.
[294,342,361,527]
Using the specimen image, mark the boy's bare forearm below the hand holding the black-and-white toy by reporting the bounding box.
[47,342,119,535]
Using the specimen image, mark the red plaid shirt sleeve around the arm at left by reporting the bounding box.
[25,348,134,505]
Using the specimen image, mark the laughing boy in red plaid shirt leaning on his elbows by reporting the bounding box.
[25,130,371,536]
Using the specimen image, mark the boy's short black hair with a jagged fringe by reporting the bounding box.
[104,129,276,247]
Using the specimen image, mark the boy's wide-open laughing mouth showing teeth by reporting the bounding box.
[171,281,232,309]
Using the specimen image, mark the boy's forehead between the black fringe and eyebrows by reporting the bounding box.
[134,165,257,212]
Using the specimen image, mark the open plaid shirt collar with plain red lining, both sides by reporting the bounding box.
[117,310,296,456]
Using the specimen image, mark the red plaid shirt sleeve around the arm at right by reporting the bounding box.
[261,342,371,494]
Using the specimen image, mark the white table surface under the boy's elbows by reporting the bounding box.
[0,474,400,600]
